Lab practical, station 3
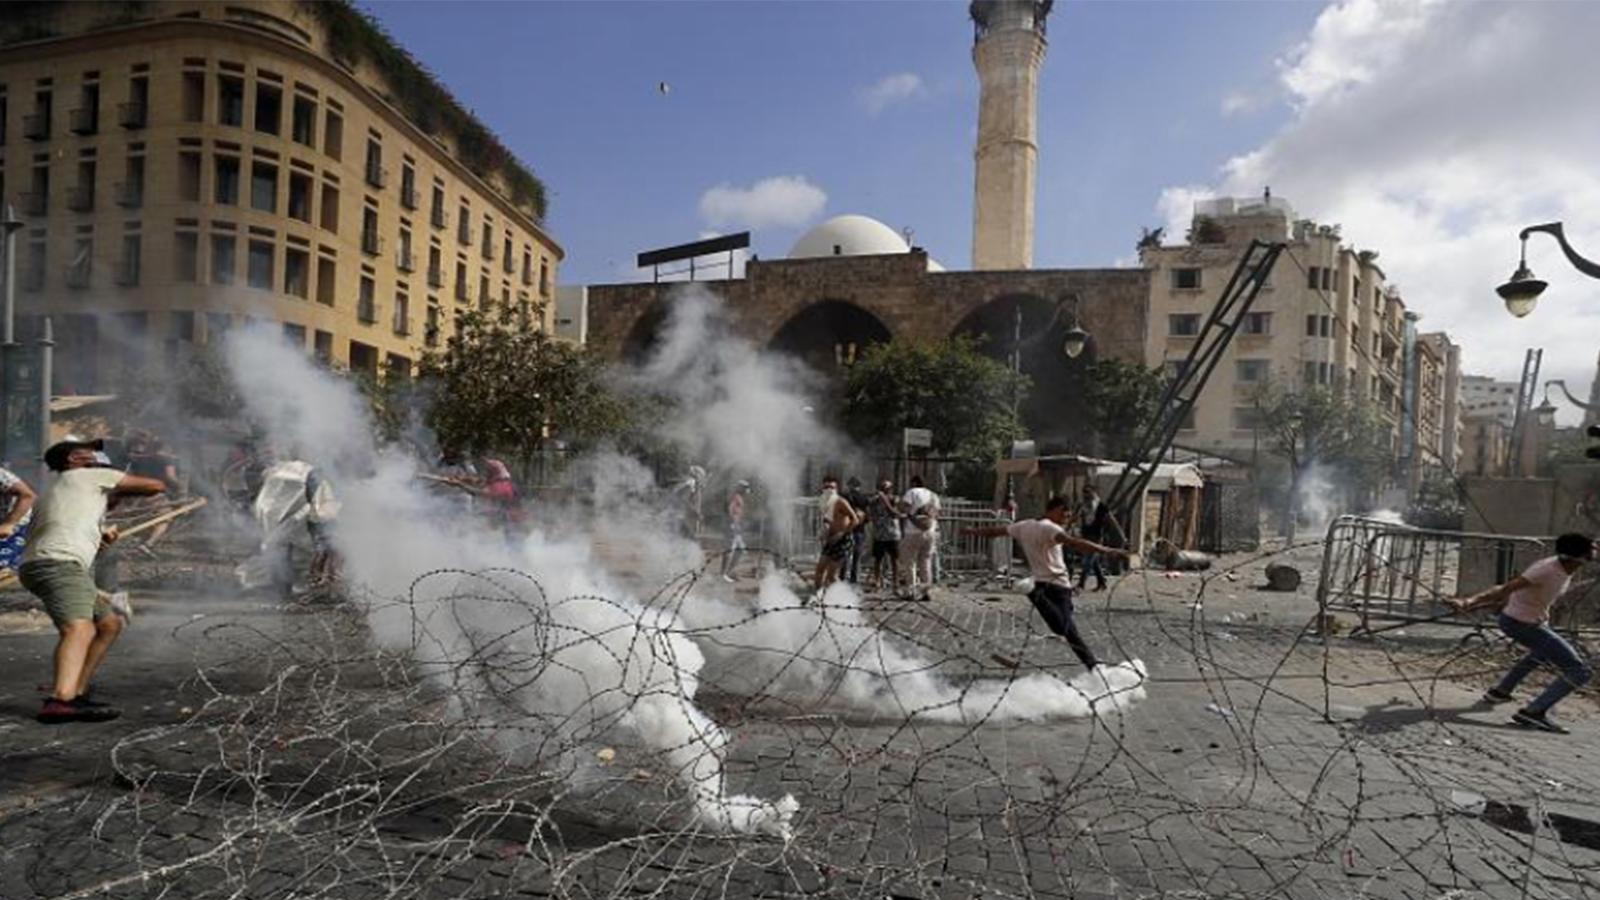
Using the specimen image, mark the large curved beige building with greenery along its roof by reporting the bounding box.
[0,0,562,392]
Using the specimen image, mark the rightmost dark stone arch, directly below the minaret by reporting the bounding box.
[950,293,1094,452]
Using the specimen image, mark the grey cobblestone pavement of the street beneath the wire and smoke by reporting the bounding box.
[0,534,1600,900]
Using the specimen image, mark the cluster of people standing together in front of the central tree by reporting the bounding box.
[813,476,939,601]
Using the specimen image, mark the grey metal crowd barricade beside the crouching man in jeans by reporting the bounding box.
[1317,516,1550,634]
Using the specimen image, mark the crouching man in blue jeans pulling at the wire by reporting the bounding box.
[1445,535,1595,735]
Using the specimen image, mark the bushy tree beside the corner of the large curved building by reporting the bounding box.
[419,312,629,453]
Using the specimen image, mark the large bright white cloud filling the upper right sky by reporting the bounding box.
[1158,0,1600,418]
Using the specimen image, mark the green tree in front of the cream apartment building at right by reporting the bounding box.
[1254,383,1392,535]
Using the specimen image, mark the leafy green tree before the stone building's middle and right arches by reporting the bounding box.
[843,336,1029,460]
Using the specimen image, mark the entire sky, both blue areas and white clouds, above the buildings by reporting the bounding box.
[363,0,1600,421]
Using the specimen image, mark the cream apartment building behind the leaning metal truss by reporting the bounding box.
[1139,195,1414,460]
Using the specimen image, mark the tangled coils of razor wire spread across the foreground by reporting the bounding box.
[0,528,1600,900]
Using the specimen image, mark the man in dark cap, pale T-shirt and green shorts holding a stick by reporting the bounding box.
[18,437,166,724]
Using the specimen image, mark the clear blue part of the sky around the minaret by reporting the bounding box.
[368,0,1320,282]
